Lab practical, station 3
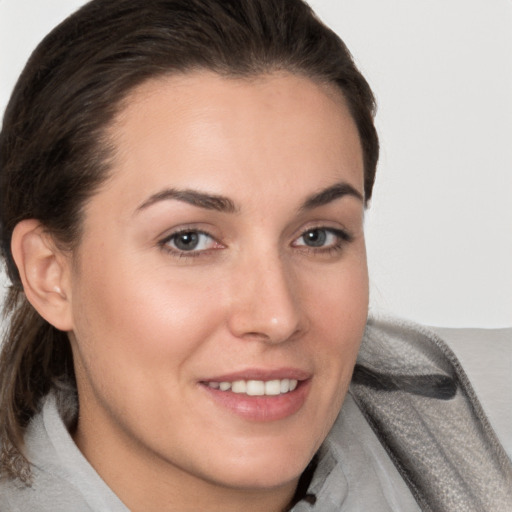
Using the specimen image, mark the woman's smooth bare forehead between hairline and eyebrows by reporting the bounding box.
[99,71,363,210]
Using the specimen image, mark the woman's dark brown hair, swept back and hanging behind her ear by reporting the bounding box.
[0,0,379,482]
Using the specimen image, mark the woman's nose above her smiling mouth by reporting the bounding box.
[228,249,305,344]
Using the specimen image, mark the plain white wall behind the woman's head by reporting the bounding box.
[0,0,512,327]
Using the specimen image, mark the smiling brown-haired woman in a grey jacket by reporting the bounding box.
[0,0,511,511]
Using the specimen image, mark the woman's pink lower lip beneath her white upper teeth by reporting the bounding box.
[201,380,310,422]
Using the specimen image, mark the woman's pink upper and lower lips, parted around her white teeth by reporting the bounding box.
[199,369,311,423]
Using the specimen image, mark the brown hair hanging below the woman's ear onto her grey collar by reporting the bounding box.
[0,286,75,483]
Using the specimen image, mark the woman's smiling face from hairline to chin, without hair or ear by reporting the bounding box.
[69,72,368,504]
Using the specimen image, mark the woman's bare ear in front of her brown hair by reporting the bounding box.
[11,219,73,331]
